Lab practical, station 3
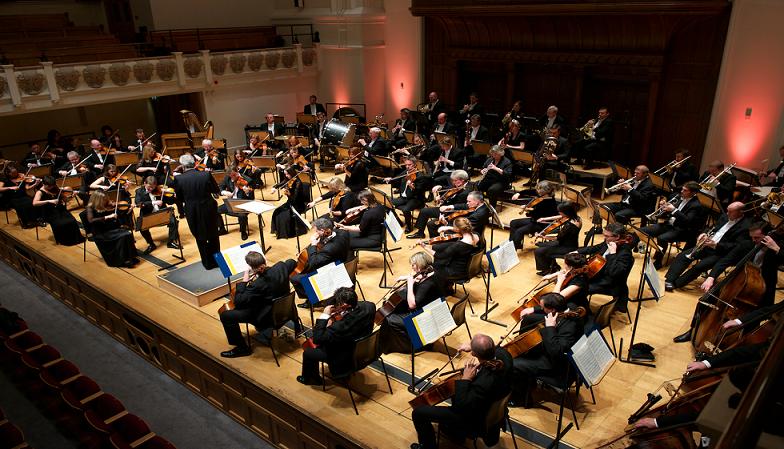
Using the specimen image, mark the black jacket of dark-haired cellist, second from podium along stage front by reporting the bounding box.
[313,301,376,376]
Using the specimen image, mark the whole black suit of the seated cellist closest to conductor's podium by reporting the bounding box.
[220,260,296,346]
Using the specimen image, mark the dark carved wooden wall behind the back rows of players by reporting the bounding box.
[411,0,730,168]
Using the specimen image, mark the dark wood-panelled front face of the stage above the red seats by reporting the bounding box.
[0,230,364,449]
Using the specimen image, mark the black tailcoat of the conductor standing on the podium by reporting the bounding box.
[174,170,219,240]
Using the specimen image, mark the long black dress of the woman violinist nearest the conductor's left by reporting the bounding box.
[85,207,137,267]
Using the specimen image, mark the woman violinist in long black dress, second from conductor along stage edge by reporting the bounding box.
[33,176,84,246]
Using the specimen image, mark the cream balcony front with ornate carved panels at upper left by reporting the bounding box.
[0,44,318,114]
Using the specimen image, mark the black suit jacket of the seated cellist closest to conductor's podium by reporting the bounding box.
[234,260,297,329]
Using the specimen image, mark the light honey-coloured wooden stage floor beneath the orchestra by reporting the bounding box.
[0,173,760,448]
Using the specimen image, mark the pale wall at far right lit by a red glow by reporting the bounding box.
[702,0,784,169]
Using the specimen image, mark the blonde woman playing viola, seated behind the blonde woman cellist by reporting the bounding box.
[418,217,484,280]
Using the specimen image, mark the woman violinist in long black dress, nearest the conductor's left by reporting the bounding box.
[83,190,139,268]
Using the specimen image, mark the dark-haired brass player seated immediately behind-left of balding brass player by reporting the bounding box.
[642,181,707,270]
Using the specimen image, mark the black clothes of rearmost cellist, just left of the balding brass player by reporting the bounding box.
[577,242,634,310]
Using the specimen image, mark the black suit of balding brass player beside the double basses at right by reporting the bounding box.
[664,215,751,288]
